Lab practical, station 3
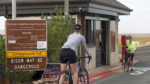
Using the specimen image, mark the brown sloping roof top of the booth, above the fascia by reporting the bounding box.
[0,0,132,11]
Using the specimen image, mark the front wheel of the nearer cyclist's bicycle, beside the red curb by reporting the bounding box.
[78,68,89,84]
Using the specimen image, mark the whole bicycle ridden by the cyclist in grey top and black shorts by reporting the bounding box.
[57,56,91,84]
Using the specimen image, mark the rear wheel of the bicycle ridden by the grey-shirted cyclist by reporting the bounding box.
[57,71,73,84]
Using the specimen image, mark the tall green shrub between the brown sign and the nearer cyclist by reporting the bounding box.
[42,7,73,63]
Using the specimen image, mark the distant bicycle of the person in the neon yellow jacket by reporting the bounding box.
[124,50,131,72]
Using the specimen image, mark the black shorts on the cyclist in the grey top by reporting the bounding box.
[59,48,77,64]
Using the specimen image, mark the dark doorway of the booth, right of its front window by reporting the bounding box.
[94,21,108,67]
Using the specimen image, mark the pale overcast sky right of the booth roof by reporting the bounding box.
[118,0,150,33]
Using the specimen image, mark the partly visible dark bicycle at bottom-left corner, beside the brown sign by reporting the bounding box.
[0,63,17,84]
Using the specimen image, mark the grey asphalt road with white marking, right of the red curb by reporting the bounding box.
[93,46,150,84]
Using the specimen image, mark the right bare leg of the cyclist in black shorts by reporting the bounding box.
[70,62,78,84]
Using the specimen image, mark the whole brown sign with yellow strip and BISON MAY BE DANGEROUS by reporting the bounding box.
[6,20,47,70]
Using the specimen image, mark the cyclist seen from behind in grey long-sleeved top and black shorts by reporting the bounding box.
[59,24,90,84]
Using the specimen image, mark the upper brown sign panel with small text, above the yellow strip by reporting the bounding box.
[6,20,47,51]
